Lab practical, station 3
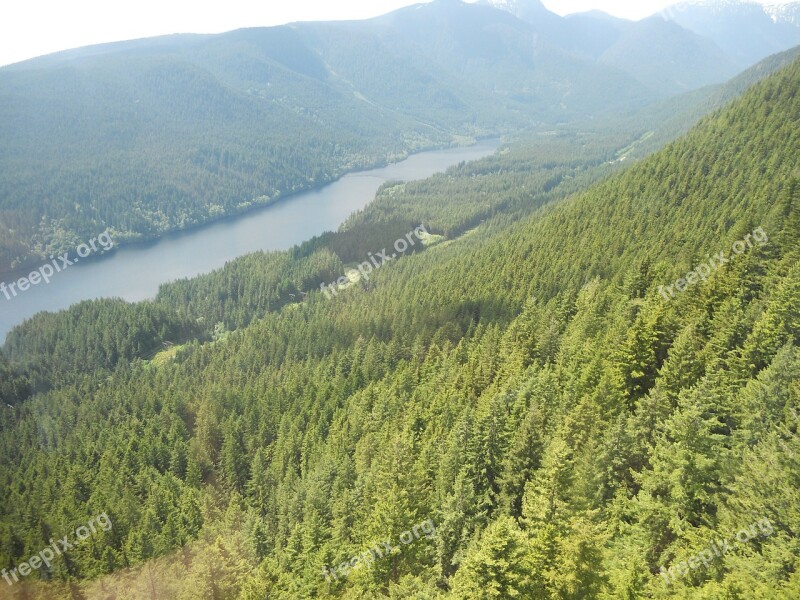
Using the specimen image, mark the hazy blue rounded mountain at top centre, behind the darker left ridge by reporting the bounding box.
[346,0,653,116]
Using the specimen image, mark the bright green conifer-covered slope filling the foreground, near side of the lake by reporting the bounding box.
[0,55,800,600]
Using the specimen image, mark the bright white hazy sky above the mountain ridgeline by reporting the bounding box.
[0,0,780,65]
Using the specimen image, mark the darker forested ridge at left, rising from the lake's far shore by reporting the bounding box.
[0,27,457,270]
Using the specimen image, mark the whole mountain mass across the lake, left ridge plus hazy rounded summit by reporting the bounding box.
[0,0,658,271]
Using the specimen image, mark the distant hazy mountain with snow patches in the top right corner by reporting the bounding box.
[660,0,800,67]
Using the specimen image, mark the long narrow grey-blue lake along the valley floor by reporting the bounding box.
[0,140,500,340]
